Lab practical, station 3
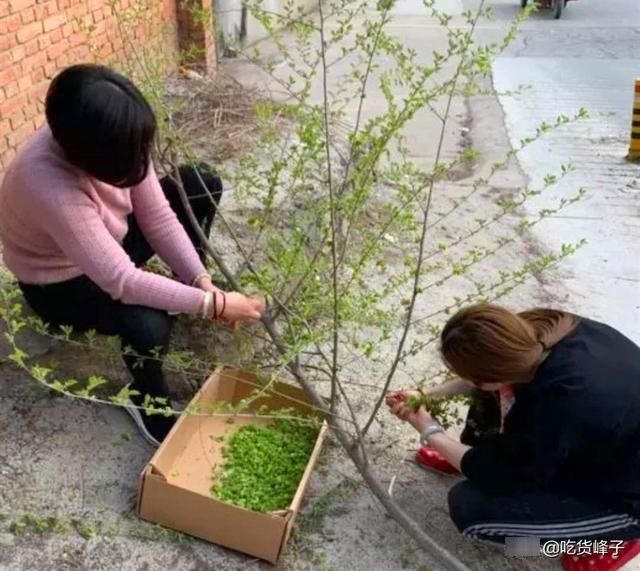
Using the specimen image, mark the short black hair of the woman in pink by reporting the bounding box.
[45,64,156,188]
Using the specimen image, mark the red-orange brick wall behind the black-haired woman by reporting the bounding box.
[0,0,212,170]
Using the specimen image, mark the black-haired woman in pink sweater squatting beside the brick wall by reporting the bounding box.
[0,65,263,445]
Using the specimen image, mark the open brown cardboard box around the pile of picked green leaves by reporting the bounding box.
[138,368,327,563]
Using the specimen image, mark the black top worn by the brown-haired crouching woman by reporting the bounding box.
[462,319,640,516]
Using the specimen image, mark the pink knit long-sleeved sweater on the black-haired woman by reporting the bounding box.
[0,127,204,313]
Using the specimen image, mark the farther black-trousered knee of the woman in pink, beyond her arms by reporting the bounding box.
[160,163,223,262]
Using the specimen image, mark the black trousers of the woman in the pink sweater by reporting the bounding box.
[20,164,222,404]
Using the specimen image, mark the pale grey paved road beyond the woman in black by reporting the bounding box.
[484,0,640,342]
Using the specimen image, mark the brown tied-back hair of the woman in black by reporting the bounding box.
[440,304,580,384]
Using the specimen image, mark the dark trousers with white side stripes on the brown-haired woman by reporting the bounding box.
[449,391,640,542]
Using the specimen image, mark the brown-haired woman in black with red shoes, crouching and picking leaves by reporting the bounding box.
[387,305,640,569]
